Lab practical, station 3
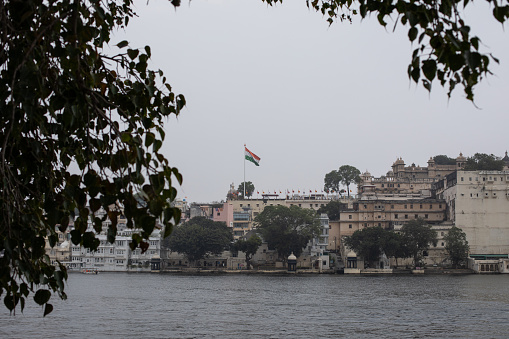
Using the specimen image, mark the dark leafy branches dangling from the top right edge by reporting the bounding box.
[262,0,509,101]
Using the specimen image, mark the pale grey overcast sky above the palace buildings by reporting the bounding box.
[115,0,509,203]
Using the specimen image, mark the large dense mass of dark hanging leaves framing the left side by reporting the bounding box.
[0,0,185,315]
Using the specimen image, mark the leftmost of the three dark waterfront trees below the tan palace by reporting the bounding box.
[344,227,387,268]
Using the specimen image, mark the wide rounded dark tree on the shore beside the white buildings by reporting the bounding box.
[165,217,233,263]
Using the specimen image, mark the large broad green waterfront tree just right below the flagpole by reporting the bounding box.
[255,206,320,262]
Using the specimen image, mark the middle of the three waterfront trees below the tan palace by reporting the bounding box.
[401,219,438,266]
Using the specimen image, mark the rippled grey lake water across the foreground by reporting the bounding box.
[0,273,509,338]
